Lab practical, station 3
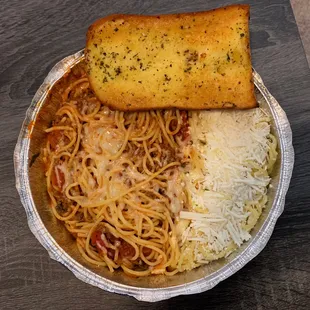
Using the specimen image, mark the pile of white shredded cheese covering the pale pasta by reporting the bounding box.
[180,108,270,269]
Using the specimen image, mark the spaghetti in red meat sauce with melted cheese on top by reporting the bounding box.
[44,63,188,276]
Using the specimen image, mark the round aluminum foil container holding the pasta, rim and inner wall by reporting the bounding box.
[14,50,294,302]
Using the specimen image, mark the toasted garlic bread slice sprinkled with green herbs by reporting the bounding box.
[85,5,257,111]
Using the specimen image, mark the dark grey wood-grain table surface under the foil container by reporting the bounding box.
[0,0,310,310]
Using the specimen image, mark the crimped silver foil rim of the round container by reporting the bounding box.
[14,50,294,302]
